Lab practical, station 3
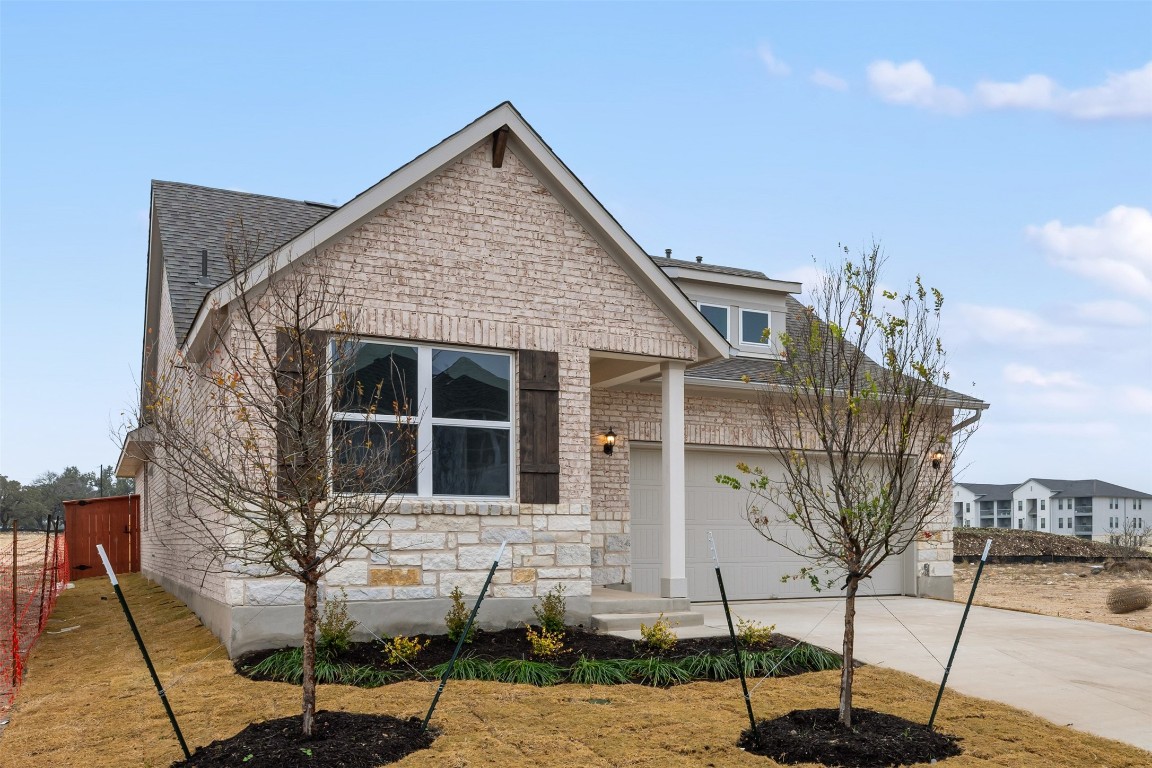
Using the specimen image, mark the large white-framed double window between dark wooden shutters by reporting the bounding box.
[333,342,513,499]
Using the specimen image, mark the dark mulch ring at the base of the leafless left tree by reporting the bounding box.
[172,710,435,768]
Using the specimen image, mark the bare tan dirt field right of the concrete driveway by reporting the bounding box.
[955,563,1152,632]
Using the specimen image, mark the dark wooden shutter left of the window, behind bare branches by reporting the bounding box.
[270,328,329,500]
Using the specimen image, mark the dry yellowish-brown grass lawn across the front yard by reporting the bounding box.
[0,577,1152,768]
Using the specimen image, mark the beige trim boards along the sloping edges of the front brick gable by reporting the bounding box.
[168,101,730,359]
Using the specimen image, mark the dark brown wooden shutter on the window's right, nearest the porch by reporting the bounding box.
[518,350,560,504]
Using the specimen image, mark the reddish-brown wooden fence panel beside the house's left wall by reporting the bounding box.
[65,494,141,580]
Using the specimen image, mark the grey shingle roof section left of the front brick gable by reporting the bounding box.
[152,181,335,343]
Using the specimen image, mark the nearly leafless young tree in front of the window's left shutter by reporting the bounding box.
[139,222,416,736]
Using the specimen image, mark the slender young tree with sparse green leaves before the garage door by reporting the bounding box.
[717,245,983,727]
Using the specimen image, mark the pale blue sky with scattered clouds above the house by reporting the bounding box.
[0,1,1152,492]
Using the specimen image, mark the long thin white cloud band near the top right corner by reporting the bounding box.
[867,60,1152,120]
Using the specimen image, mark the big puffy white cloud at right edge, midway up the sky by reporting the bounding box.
[1025,205,1152,298]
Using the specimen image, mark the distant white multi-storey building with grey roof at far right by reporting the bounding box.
[952,478,1152,541]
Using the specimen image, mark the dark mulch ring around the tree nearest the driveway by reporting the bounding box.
[737,709,961,768]
